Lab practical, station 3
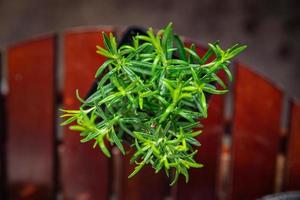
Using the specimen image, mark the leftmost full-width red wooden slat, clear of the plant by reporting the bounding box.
[6,36,55,199]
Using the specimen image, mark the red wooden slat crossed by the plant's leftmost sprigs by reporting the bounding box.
[61,28,111,200]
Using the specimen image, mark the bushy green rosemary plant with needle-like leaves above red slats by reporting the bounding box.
[61,23,246,185]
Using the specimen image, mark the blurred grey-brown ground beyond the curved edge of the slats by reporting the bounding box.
[0,0,300,97]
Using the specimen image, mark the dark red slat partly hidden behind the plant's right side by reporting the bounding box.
[177,44,225,200]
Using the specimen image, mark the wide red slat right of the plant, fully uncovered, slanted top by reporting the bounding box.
[230,64,283,200]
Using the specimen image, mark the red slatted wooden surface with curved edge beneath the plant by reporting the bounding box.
[0,27,300,200]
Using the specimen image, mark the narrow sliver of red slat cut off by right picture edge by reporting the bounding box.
[285,101,300,190]
